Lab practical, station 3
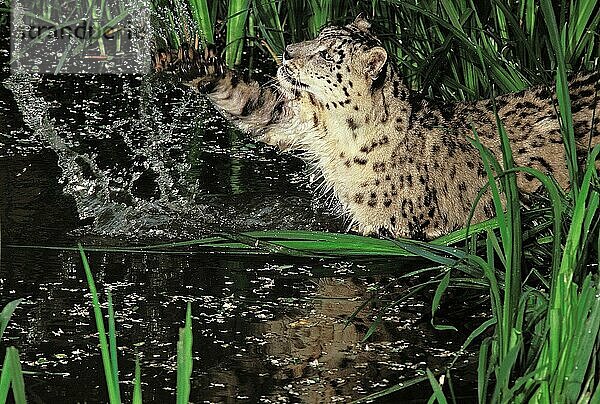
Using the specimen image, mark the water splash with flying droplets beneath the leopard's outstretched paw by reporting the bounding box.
[4,73,336,238]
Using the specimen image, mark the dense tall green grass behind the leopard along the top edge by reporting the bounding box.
[153,0,600,90]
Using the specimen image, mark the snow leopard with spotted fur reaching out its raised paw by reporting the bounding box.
[157,18,600,239]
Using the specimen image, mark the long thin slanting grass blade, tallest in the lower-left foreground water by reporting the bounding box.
[78,244,121,404]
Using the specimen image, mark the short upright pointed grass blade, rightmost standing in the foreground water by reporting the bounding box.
[177,302,193,404]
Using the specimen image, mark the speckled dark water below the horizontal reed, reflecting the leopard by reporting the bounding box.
[1,248,474,403]
